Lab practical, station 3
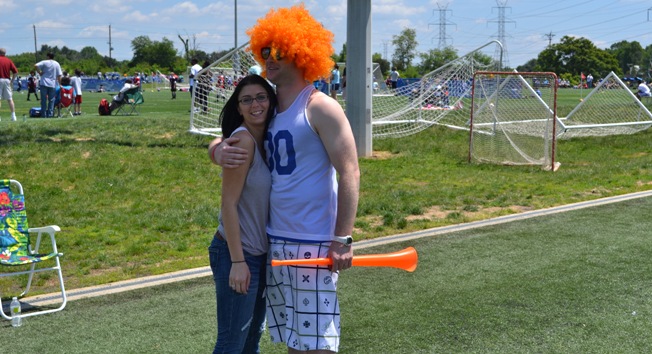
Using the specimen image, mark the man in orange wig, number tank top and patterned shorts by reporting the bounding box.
[212,5,360,353]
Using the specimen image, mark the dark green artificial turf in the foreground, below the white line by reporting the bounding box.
[0,198,652,354]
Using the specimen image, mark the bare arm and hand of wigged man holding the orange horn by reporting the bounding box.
[308,94,360,271]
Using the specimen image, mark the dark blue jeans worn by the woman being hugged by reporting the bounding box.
[208,237,267,354]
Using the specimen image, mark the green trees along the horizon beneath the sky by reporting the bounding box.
[8,28,652,83]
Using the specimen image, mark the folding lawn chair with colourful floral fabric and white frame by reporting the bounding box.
[0,179,67,320]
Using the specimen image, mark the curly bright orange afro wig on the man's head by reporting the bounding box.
[247,4,335,82]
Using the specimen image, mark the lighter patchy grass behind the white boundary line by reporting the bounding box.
[0,85,652,298]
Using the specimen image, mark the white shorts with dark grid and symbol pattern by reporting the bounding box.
[267,238,340,352]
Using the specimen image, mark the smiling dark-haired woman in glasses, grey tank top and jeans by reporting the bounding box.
[208,75,277,353]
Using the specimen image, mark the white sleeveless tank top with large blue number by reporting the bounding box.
[265,85,337,242]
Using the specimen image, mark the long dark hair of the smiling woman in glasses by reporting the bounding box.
[220,75,278,138]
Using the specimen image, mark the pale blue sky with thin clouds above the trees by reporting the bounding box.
[0,0,652,67]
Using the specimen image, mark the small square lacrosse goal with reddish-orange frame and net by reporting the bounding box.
[469,71,559,171]
